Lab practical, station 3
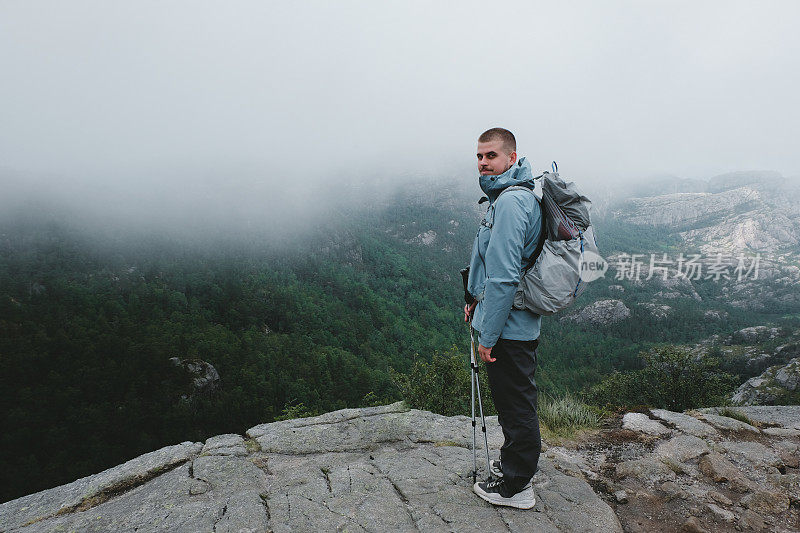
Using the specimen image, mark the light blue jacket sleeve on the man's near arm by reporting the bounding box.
[479,193,541,348]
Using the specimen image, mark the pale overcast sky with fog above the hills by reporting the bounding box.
[0,0,800,218]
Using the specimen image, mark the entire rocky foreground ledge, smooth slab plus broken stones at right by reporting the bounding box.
[0,403,800,533]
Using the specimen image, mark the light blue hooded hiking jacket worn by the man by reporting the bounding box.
[467,157,542,348]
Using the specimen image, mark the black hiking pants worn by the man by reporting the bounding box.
[485,338,542,492]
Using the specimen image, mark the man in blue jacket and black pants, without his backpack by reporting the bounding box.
[464,128,542,509]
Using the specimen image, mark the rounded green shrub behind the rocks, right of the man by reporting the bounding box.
[588,345,735,411]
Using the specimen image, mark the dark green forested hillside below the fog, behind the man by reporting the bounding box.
[0,184,800,501]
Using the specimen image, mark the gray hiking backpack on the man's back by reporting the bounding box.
[498,162,600,315]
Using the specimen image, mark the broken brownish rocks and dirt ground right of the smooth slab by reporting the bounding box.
[608,406,800,532]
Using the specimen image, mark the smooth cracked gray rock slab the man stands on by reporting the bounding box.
[0,403,622,533]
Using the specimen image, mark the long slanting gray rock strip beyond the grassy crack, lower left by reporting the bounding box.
[0,442,202,530]
